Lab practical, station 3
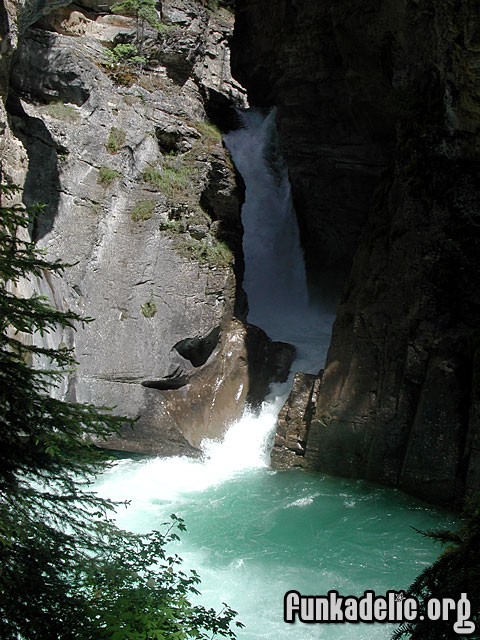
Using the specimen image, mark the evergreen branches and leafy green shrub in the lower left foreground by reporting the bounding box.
[0,187,240,640]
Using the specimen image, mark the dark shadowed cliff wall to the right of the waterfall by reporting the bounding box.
[233,0,480,504]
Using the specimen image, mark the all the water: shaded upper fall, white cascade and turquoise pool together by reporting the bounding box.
[97,111,451,640]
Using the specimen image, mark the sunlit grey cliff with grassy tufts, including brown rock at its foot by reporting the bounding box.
[2,0,293,454]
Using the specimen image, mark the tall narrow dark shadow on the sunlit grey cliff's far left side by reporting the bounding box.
[6,92,61,241]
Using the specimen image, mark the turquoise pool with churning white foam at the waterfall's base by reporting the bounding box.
[98,424,451,640]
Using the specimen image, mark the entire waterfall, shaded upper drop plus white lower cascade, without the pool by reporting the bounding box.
[99,110,333,501]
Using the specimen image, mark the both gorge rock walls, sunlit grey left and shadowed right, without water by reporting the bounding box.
[0,0,480,506]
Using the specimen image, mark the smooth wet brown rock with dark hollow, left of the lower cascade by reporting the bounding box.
[102,319,294,455]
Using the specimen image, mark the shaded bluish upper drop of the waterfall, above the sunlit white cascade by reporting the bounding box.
[224,109,334,373]
